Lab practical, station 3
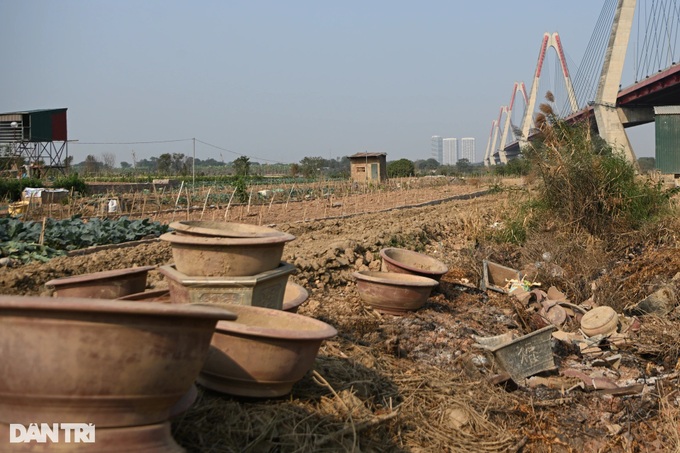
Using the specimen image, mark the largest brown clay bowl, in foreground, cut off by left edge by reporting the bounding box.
[0,296,236,428]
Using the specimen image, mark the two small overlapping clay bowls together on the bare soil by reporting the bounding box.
[354,248,448,315]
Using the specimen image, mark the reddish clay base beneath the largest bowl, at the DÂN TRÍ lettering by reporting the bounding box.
[0,422,185,453]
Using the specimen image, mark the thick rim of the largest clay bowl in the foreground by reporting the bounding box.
[0,296,237,320]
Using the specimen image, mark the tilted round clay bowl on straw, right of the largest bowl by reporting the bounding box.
[197,305,337,398]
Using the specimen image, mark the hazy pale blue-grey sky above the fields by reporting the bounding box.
[0,0,653,163]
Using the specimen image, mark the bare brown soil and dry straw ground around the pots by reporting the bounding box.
[0,178,680,452]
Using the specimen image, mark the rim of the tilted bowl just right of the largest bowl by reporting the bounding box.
[215,305,338,340]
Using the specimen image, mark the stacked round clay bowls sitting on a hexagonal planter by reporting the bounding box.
[160,221,295,310]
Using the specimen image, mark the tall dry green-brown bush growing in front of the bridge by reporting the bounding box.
[523,100,669,237]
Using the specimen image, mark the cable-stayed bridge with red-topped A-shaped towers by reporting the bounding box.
[484,0,680,166]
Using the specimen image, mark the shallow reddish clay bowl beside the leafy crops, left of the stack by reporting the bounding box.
[45,266,155,299]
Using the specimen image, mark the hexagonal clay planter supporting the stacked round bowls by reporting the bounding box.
[159,262,295,310]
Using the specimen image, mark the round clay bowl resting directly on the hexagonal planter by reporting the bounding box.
[161,232,295,277]
